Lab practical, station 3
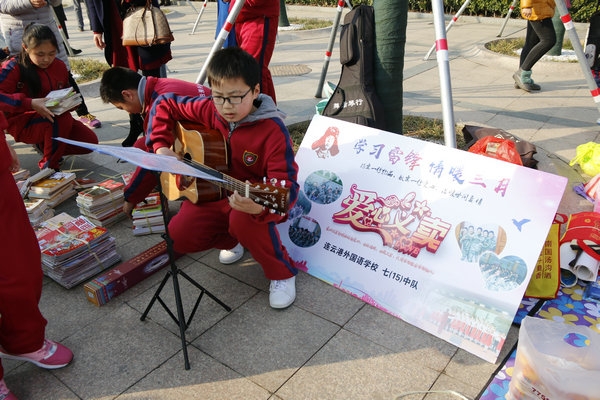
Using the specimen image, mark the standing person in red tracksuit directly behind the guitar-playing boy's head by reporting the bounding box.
[229,0,279,103]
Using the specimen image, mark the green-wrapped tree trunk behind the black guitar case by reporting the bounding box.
[373,0,408,135]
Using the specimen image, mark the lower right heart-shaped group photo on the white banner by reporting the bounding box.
[479,251,527,292]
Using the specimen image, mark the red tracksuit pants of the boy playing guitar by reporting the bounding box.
[168,198,298,280]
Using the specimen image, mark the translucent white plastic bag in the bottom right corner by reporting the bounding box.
[506,317,600,400]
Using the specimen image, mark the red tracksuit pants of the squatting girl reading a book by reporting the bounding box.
[8,112,98,170]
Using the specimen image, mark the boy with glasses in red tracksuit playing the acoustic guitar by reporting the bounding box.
[146,47,299,308]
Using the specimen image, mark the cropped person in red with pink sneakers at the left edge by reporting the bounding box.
[0,120,73,400]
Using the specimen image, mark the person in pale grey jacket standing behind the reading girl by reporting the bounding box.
[0,0,102,128]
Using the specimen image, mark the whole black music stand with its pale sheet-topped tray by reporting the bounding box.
[54,138,231,369]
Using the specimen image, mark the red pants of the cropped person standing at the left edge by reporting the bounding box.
[0,170,46,379]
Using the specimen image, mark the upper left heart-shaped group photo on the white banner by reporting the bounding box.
[456,221,506,262]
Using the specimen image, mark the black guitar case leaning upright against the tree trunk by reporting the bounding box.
[322,5,385,129]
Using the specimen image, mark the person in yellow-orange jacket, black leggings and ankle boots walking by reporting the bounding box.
[513,0,556,92]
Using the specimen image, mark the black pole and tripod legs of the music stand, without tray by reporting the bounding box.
[140,171,231,369]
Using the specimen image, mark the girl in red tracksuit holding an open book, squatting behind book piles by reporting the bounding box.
[0,24,98,170]
